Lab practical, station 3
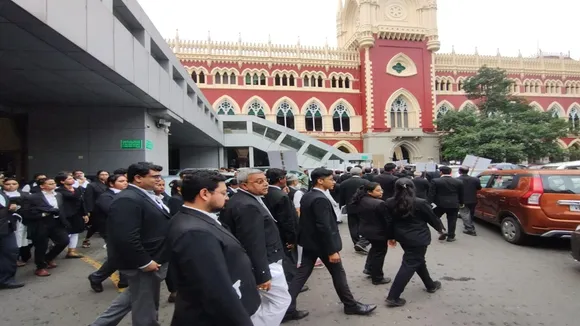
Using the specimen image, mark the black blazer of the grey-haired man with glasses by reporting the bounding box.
[220,190,284,284]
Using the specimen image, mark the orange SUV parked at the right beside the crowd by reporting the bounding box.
[475,170,580,244]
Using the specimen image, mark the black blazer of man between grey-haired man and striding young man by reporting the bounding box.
[264,186,298,244]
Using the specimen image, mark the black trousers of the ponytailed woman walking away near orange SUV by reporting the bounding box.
[387,244,434,300]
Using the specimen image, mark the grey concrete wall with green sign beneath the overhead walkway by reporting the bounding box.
[28,108,168,177]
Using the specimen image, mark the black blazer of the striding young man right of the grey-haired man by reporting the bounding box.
[298,189,342,256]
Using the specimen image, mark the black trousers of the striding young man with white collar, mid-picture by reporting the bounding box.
[288,248,357,312]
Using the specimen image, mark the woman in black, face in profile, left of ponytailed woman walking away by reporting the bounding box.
[351,182,391,285]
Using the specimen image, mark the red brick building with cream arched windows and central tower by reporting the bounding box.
[168,0,580,165]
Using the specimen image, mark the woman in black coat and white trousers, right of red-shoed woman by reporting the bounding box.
[54,172,89,258]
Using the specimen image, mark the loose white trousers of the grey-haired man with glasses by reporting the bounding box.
[251,261,292,326]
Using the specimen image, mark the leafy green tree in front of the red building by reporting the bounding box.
[435,66,569,163]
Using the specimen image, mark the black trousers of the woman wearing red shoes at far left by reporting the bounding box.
[32,217,69,269]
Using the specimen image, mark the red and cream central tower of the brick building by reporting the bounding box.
[337,0,440,163]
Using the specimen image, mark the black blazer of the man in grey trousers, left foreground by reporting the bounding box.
[107,185,171,269]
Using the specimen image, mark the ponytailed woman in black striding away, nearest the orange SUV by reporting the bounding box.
[386,178,445,307]
